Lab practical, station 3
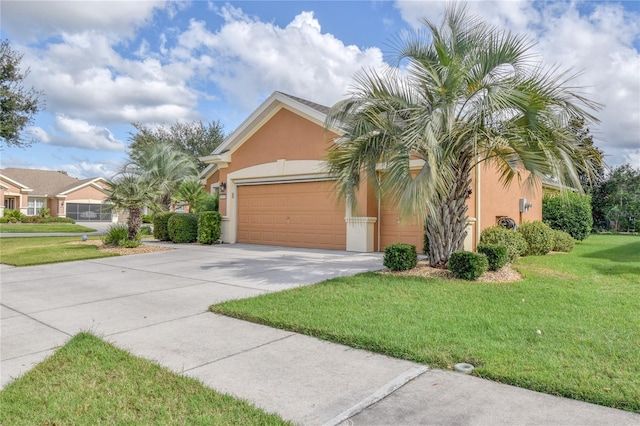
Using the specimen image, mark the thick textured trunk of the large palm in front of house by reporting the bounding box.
[427,155,472,269]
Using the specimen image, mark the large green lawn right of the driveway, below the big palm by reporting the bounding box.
[211,235,640,412]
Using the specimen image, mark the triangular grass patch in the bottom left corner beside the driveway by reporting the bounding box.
[0,333,288,426]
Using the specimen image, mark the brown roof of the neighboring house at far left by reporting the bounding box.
[0,168,105,197]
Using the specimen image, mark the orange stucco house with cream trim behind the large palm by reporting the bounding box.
[200,92,542,252]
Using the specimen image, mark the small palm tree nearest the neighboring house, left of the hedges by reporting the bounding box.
[106,172,159,241]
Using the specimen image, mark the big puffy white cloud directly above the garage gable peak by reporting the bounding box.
[172,6,382,110]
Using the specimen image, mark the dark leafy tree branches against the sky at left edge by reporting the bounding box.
[0,40,44,147]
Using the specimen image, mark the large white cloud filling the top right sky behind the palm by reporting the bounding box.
[396,0,640,165]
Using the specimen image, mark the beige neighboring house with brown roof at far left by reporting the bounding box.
[0,168,117,222]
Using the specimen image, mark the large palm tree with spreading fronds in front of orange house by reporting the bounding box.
[326,5,598,267]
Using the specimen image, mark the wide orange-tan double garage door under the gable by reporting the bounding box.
[237,181,346,250]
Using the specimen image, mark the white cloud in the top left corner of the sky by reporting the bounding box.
[2,0,171,40]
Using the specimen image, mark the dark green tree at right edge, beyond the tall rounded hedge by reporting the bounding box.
[591,164,640,232]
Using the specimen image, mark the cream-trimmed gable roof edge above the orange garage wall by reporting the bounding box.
[200,92,330,179]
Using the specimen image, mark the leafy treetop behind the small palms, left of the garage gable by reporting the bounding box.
[129,121,224,171]
